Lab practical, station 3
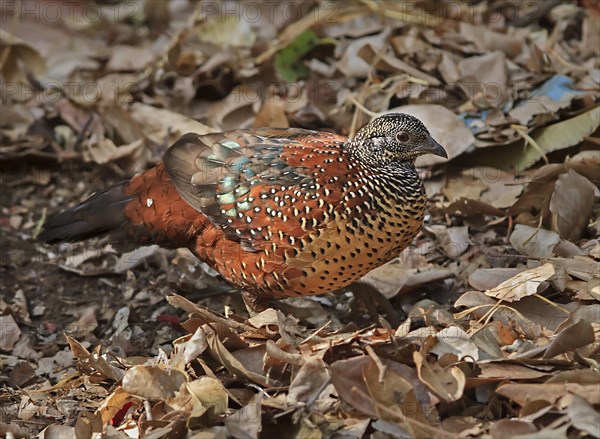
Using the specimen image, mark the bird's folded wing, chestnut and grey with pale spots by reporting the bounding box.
[164,128,352,250]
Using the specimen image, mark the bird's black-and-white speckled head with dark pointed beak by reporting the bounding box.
[350,113,448,165]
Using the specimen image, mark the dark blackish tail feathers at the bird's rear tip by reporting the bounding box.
[37,182,133,244]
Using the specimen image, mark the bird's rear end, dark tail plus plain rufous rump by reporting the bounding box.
[37,163,205,251]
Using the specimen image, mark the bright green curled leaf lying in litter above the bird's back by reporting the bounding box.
[275,30,336,82]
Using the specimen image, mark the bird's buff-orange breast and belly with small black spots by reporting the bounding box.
[285,177,426,295]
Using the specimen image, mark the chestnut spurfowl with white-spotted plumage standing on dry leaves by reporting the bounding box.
[37,113,448,314]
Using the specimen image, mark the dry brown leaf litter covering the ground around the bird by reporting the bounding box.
[0,0,600,438]
